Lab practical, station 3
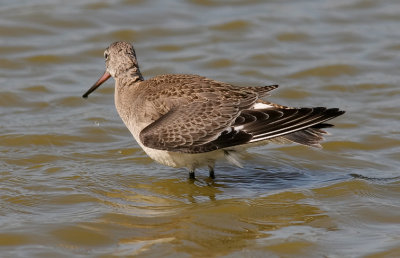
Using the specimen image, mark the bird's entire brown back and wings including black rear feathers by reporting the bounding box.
[140,75,344,153]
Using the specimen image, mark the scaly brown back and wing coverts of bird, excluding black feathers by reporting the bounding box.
[140,78,278,153]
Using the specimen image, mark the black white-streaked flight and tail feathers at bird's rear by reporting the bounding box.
[196,107,344,150]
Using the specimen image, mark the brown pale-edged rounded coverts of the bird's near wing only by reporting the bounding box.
[140,100,248,153]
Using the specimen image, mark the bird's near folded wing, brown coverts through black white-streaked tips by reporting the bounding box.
[140,102,344,153]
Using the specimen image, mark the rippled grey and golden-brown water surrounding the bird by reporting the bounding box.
[0,0,400,257]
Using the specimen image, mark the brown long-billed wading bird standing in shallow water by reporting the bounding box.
[82,41,345,179]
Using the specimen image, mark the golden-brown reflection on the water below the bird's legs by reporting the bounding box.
[91,180,336,256]
